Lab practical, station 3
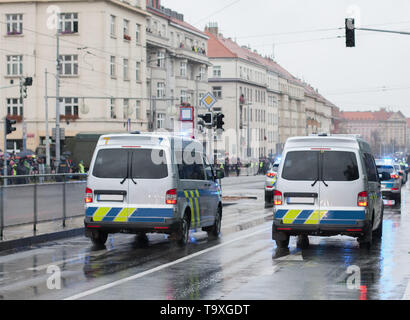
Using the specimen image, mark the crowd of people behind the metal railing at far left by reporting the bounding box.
[0,154,86,185]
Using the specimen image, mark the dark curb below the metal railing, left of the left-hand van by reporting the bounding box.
[0,228,84,252]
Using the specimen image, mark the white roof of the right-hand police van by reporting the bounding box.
[285,135,371,153]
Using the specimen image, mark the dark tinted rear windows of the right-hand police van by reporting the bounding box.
[282,151,359,181]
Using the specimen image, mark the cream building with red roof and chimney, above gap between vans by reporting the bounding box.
[206,24,280,159]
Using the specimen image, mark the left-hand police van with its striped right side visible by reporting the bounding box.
[84,133,223,246]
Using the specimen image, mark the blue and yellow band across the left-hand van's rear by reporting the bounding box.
[85,207,174,223]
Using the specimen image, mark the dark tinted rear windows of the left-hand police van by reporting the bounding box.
[93,149,168,179]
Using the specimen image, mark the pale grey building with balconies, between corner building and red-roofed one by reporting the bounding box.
[146,0,210,131]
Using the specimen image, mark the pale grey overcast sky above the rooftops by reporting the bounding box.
[162,0,410,117]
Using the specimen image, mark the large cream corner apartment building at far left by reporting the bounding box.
[0,0,150,151]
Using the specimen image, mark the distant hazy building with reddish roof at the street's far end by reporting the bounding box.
[341,108,407,155]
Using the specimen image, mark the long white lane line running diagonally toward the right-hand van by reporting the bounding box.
[64,226,272,300]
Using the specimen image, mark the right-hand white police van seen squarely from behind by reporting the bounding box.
[272,135,390,248]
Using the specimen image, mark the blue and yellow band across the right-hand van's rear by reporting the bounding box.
[274,209,366,225]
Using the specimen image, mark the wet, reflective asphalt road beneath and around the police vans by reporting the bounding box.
[0,177,410,300]
